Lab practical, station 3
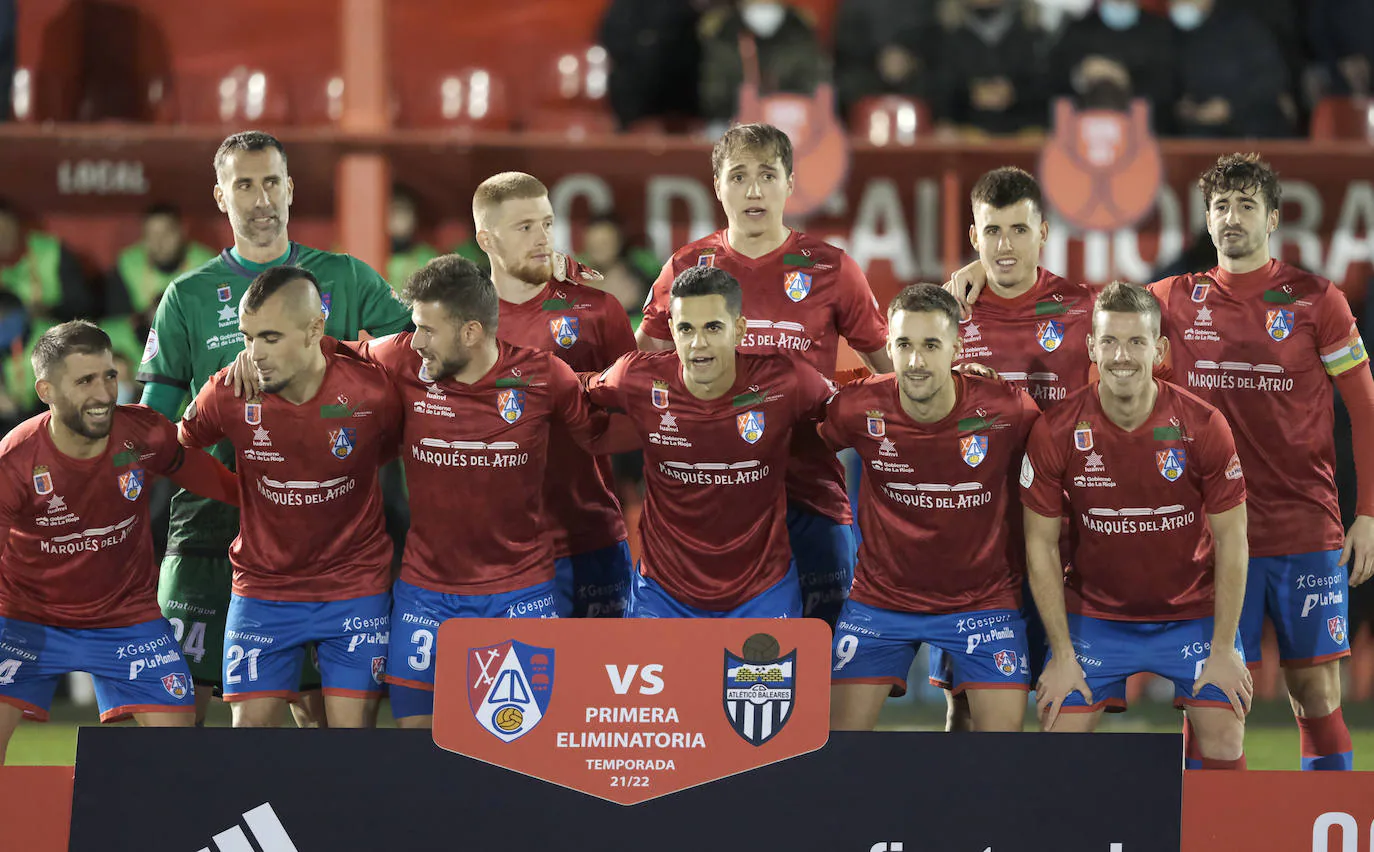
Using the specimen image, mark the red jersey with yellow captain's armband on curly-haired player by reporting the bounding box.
[1151,260,1369,557]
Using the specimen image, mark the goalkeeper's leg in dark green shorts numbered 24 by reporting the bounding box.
[158,555,234,724]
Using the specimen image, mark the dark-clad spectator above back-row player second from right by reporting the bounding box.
[934,0,1050,135]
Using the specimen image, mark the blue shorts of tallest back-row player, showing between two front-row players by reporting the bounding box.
[787,504,859,625]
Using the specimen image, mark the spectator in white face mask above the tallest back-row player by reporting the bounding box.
[698,0,830,121]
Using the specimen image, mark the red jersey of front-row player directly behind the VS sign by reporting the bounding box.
[588,352,831,612]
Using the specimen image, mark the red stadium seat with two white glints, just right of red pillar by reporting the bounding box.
[396,67,511,131]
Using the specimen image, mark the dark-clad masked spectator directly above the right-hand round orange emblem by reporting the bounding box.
[1050,0,1178,132]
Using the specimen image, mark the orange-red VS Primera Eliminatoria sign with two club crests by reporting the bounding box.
[434,618,830,805]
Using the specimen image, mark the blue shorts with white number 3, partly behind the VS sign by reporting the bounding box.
[386,580,567,719]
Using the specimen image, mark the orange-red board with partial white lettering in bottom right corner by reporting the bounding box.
[1183,771,1374,852]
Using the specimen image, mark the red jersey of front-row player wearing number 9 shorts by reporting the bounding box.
[820,374,1040,613]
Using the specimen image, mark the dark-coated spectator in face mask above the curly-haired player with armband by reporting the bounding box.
[1169,0,1294,137]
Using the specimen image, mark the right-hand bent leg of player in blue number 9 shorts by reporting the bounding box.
[927,609,1031,731]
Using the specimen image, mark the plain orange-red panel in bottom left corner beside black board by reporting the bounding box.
[0,767,74,852]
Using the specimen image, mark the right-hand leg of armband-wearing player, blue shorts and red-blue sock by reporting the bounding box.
[1270,550,1353,771]
